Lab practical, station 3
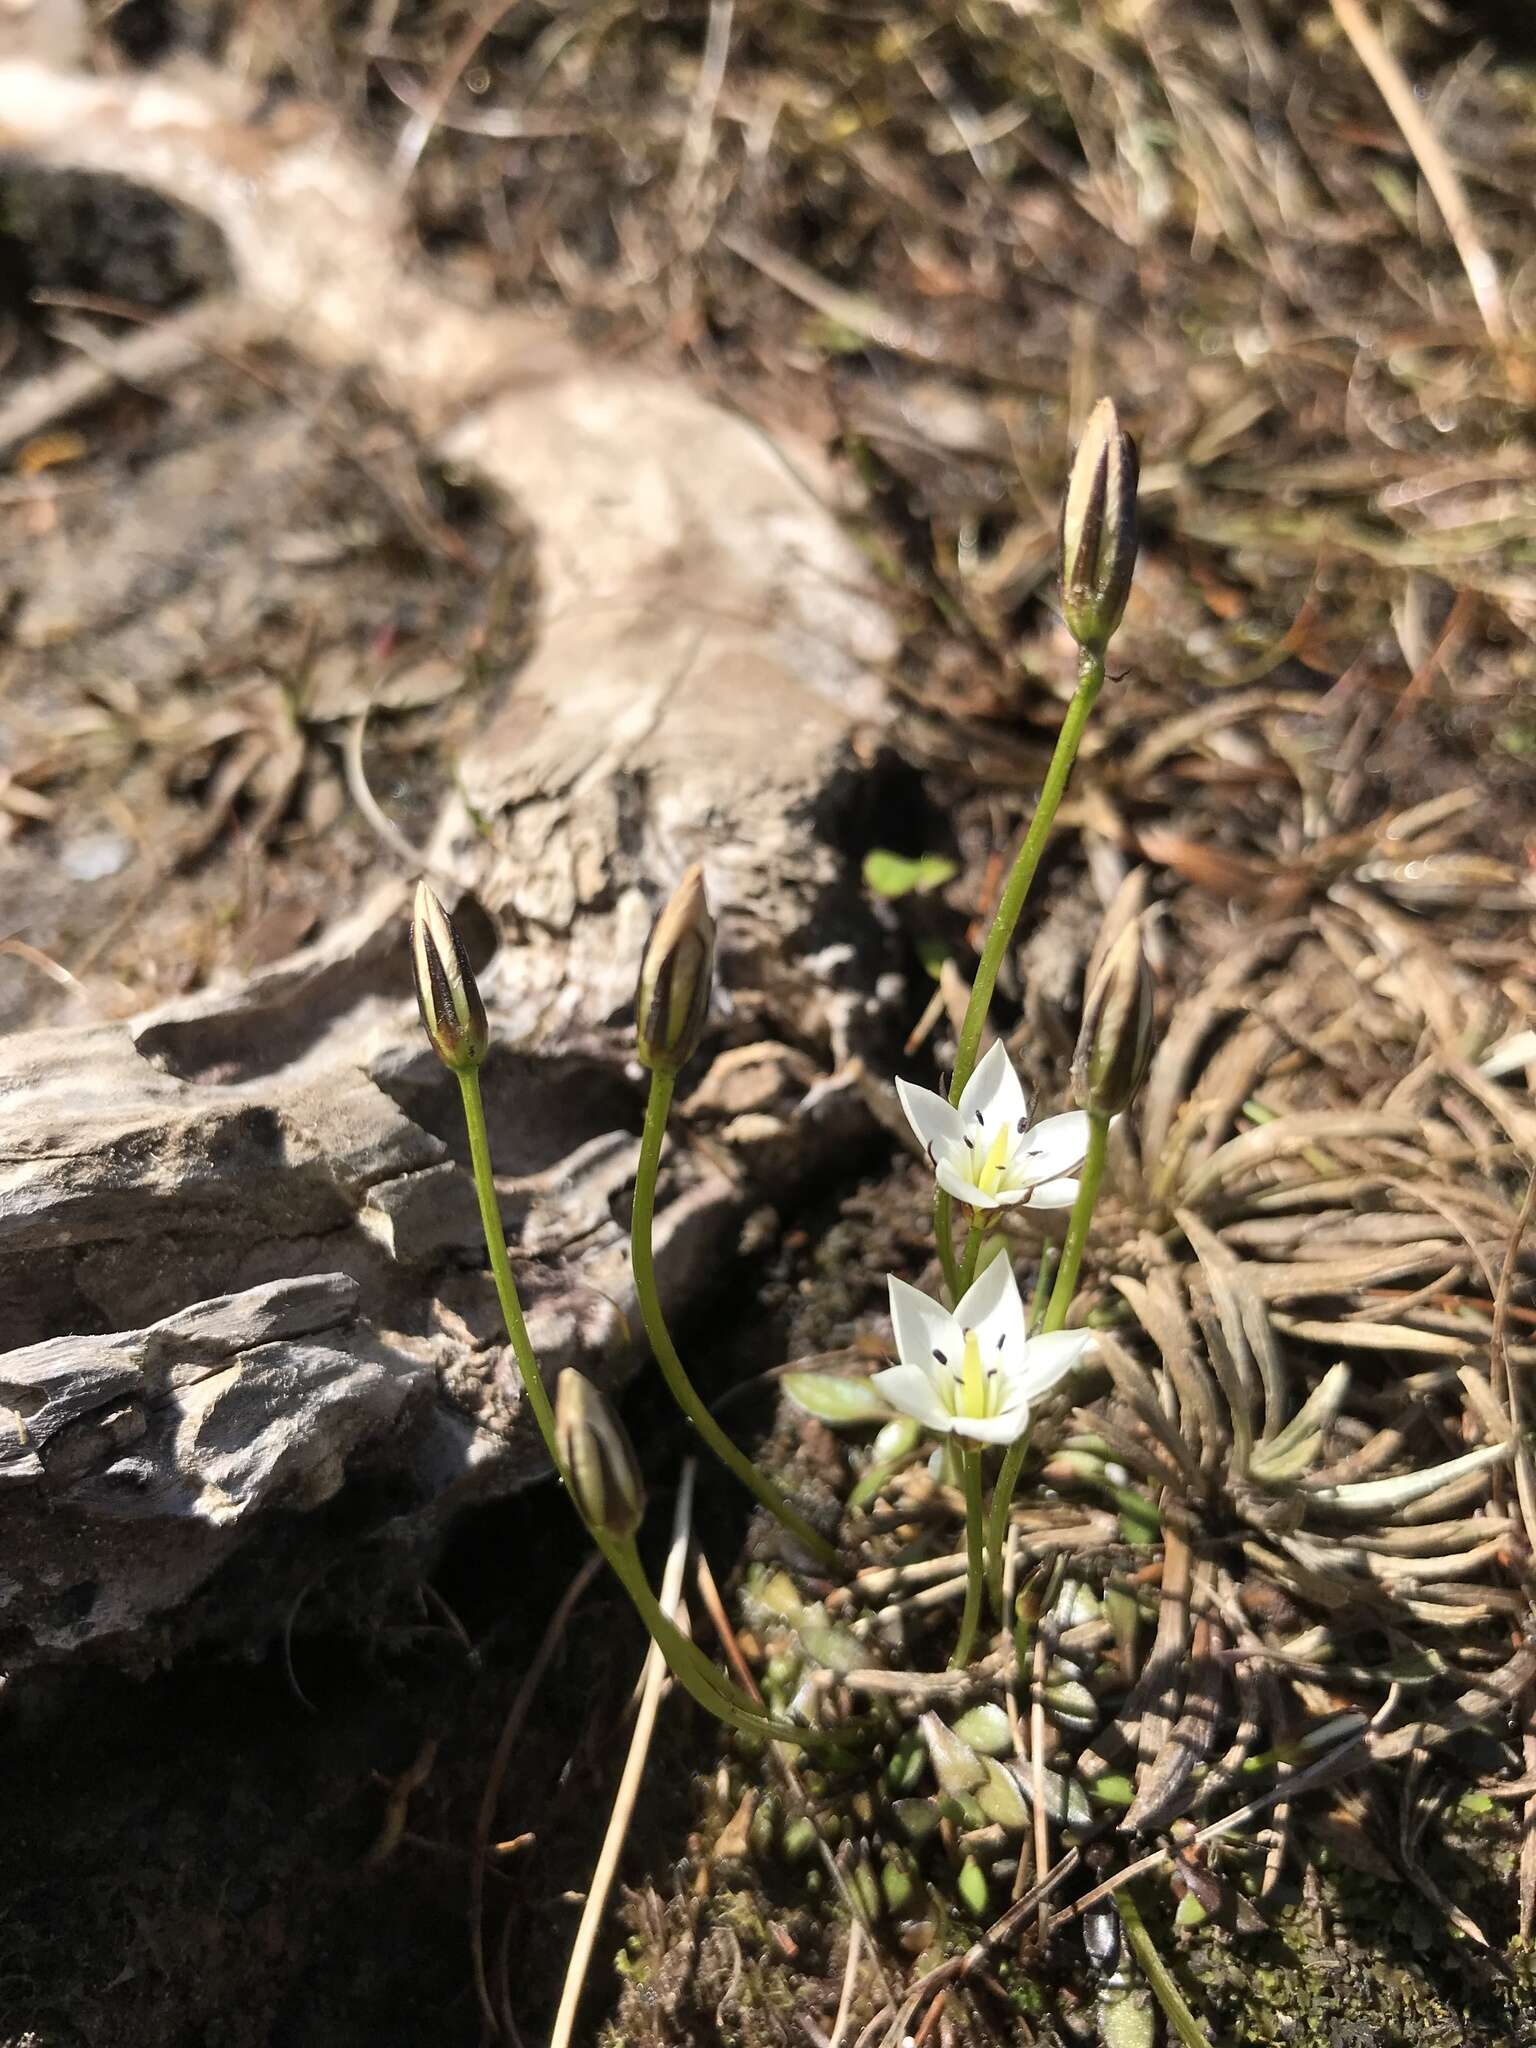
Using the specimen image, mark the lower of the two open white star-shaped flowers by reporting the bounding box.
[872,1257,1094,1444]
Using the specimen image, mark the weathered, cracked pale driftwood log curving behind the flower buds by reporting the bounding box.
[0,48,891,1669]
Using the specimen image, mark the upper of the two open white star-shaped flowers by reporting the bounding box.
[897,1038,1087,1208]
